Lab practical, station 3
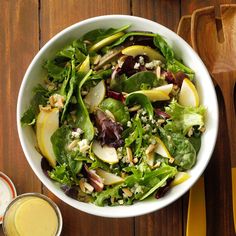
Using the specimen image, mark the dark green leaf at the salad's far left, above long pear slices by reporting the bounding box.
[20,85,51,125]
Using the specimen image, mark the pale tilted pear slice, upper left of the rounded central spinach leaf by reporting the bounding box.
[84,80,106,112]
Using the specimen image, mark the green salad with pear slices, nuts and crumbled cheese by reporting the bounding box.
[21,26,206,206]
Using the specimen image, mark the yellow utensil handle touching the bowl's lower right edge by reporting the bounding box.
[186,176,206,236]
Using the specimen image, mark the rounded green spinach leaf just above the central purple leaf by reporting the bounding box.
[99,98,130,126]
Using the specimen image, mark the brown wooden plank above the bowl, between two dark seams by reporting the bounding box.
[40,0,130,45]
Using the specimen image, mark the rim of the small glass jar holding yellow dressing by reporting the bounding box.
[2,193,63,236]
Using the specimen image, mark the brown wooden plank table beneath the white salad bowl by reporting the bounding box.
[0,0,236,236]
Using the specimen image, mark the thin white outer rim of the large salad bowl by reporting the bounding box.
[16,14,219,218]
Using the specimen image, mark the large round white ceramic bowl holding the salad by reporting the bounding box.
[17,15,218,217]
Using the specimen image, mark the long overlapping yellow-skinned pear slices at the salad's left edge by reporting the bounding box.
[36,108,59,167]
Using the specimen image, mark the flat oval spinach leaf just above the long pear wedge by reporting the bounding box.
[122,71,157,93]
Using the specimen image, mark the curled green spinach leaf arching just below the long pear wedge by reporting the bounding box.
[125,92,153,119]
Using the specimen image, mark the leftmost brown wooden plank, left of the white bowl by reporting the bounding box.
[0,0,41,235]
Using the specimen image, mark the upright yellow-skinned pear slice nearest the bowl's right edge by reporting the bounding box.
[178,78,199,107]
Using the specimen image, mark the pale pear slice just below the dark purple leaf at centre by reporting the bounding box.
[92,141,119,164]
